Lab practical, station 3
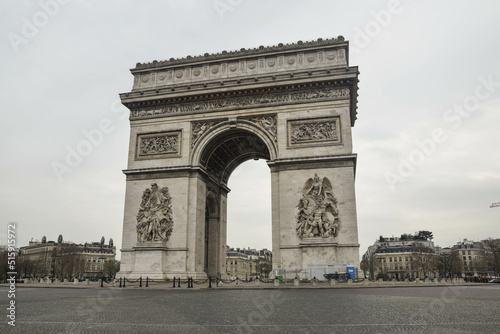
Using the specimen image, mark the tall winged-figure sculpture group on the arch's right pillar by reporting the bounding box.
[296,174,340,238]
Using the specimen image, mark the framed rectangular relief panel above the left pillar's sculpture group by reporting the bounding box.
[135,130,182,160]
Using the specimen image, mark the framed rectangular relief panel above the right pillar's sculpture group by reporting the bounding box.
[287,116,342,147]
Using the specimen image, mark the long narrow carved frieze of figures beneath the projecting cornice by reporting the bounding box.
[130,87,350,119]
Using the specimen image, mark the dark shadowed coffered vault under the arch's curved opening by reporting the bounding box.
[200,129,270,184]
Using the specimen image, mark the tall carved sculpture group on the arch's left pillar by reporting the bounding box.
[136,183,174,242]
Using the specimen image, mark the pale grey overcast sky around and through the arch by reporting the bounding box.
[0,0,500,260]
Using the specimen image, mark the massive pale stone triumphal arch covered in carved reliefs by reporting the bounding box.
[120,36,359,278]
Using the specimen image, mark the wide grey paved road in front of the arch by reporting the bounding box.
[0,284,500,333]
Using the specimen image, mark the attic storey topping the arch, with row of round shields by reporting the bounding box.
[131,38,349,92]
